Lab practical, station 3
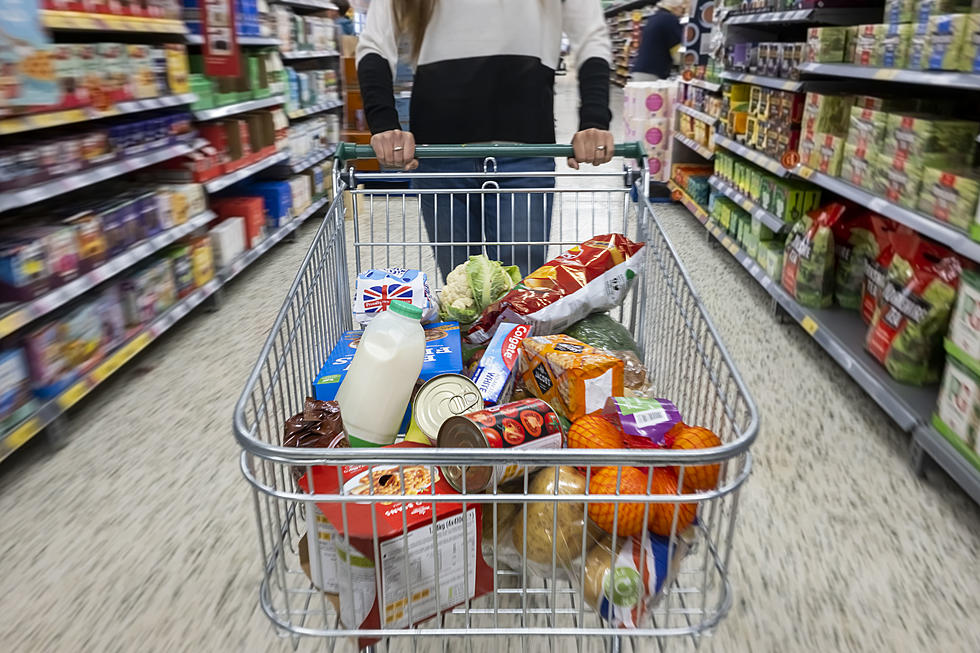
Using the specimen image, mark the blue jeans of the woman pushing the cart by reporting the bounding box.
[412,158,555,278]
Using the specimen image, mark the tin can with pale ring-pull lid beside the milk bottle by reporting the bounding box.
[405,374,483,445]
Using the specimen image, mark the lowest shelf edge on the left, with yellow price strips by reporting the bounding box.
[0,279,222,460]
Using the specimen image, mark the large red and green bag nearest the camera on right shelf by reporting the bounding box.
[865,236,962,385]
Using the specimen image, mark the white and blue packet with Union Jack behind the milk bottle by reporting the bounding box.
[352,268,437,327]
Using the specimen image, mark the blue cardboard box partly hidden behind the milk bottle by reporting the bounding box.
[313,322,463,433]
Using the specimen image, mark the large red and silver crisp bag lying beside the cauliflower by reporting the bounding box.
[467,234,643,343]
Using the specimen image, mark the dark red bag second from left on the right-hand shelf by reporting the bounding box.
[833,211,885,311]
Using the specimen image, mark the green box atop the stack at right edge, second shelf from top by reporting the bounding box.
[881,113,980,167]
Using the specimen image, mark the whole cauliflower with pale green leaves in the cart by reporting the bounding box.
[439,254,521,324]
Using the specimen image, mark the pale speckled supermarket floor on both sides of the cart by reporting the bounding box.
[0,76,980,653]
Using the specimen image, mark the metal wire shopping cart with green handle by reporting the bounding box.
[234,145,758,651]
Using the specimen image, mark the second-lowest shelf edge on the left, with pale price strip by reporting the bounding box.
[0,211,216,338]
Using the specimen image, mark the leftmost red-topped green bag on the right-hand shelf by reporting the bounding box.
[783,203,845,308]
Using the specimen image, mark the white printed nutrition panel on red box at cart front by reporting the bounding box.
[381,508,476,628]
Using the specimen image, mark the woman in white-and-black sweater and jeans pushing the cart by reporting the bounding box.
[357,0,613,276]
